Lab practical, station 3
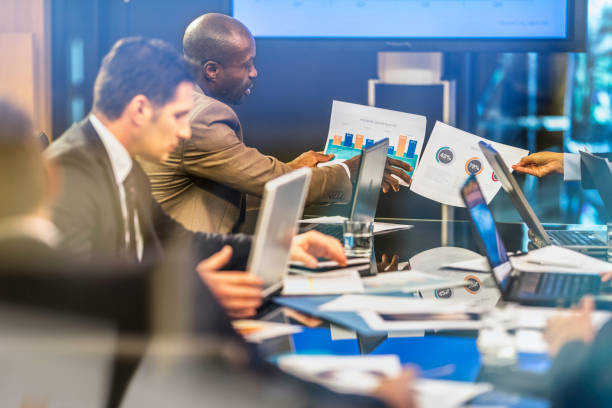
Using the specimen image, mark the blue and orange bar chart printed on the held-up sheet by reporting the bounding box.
[325,133,419,176]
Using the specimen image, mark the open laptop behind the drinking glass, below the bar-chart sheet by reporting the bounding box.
[304,138,389,241]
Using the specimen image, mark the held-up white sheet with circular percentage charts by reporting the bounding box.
[410,122,529,207]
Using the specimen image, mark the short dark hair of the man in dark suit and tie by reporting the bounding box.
[93,37,193,119]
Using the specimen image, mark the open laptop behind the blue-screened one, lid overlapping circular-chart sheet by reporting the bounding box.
[479,141,609,256]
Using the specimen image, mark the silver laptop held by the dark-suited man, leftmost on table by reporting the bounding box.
[247,168,312,297]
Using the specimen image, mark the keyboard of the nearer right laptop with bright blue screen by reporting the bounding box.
[532,273,600,299]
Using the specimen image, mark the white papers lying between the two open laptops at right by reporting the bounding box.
[510,245,612,274]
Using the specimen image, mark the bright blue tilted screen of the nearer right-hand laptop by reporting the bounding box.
[461,176,512,290]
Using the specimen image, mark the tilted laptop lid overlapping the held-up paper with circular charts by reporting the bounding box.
[478,141,551,245]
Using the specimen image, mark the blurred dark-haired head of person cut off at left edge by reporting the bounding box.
[0,99,47,218]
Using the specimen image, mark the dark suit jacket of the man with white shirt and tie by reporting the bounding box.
[46,119,251,269]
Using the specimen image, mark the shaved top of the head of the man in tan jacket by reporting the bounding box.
[183,13,253,64]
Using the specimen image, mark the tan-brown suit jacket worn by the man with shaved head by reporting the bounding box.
[141,86,352,233]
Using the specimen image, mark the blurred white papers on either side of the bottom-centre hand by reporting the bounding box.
[278,355,492,408]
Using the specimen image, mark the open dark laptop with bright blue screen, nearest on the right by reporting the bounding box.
[461,176,601,306]
